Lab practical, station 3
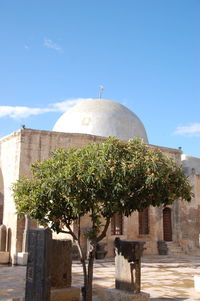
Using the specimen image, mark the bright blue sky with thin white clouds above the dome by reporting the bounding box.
[0,0,200,157]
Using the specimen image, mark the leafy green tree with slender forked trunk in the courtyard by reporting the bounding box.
[13,137,191,301]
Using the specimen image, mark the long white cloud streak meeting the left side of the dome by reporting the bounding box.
[0,98,89,119]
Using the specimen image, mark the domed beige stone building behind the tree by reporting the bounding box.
[0,99,200,264]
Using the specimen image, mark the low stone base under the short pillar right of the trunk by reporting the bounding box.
[104,288,150,301]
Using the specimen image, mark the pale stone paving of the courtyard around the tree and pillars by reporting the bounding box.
[0,255,200,301]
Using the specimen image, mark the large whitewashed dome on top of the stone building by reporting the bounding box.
[53,99,148,143]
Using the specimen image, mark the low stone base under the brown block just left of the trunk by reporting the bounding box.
[50,286,80,301]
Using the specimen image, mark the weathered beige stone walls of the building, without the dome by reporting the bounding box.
[0,129,200,262]
